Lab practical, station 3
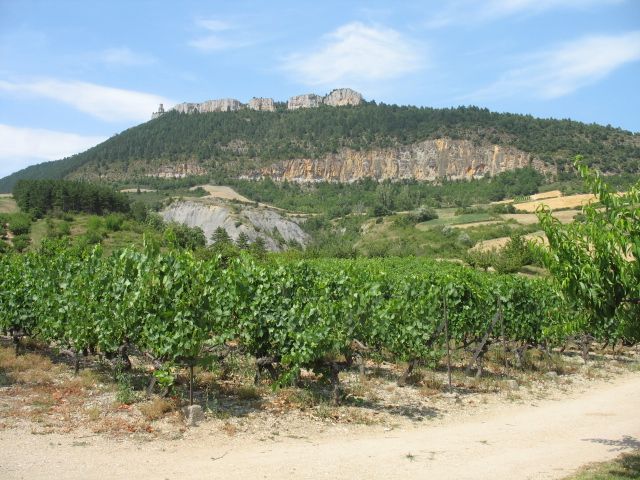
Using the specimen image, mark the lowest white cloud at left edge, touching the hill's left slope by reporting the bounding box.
[0,124,106,178]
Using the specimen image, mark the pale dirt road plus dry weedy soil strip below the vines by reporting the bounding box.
[0,348,640,479]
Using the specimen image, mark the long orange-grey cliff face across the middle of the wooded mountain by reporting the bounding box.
[245,138,550,182]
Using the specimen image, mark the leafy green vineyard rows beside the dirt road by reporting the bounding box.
[0,243,625,402]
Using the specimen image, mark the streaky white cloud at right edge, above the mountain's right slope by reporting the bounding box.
[469,31,640,99]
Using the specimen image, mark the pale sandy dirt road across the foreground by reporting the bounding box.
[0,373,640,480]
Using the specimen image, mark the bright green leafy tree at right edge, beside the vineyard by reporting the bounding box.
[537,156,640,340]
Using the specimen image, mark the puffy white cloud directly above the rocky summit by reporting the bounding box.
[282,22,424,86]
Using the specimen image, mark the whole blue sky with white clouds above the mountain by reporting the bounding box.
[0,0,640,177]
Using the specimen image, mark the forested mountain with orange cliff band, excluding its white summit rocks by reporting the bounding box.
[0,100,640,192]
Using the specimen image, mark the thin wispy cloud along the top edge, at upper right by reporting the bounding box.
[427,0,624,28]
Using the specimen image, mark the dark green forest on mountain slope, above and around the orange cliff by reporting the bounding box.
[0,103,640,192]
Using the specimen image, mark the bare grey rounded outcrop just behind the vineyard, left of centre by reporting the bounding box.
[160,201,309,251]
